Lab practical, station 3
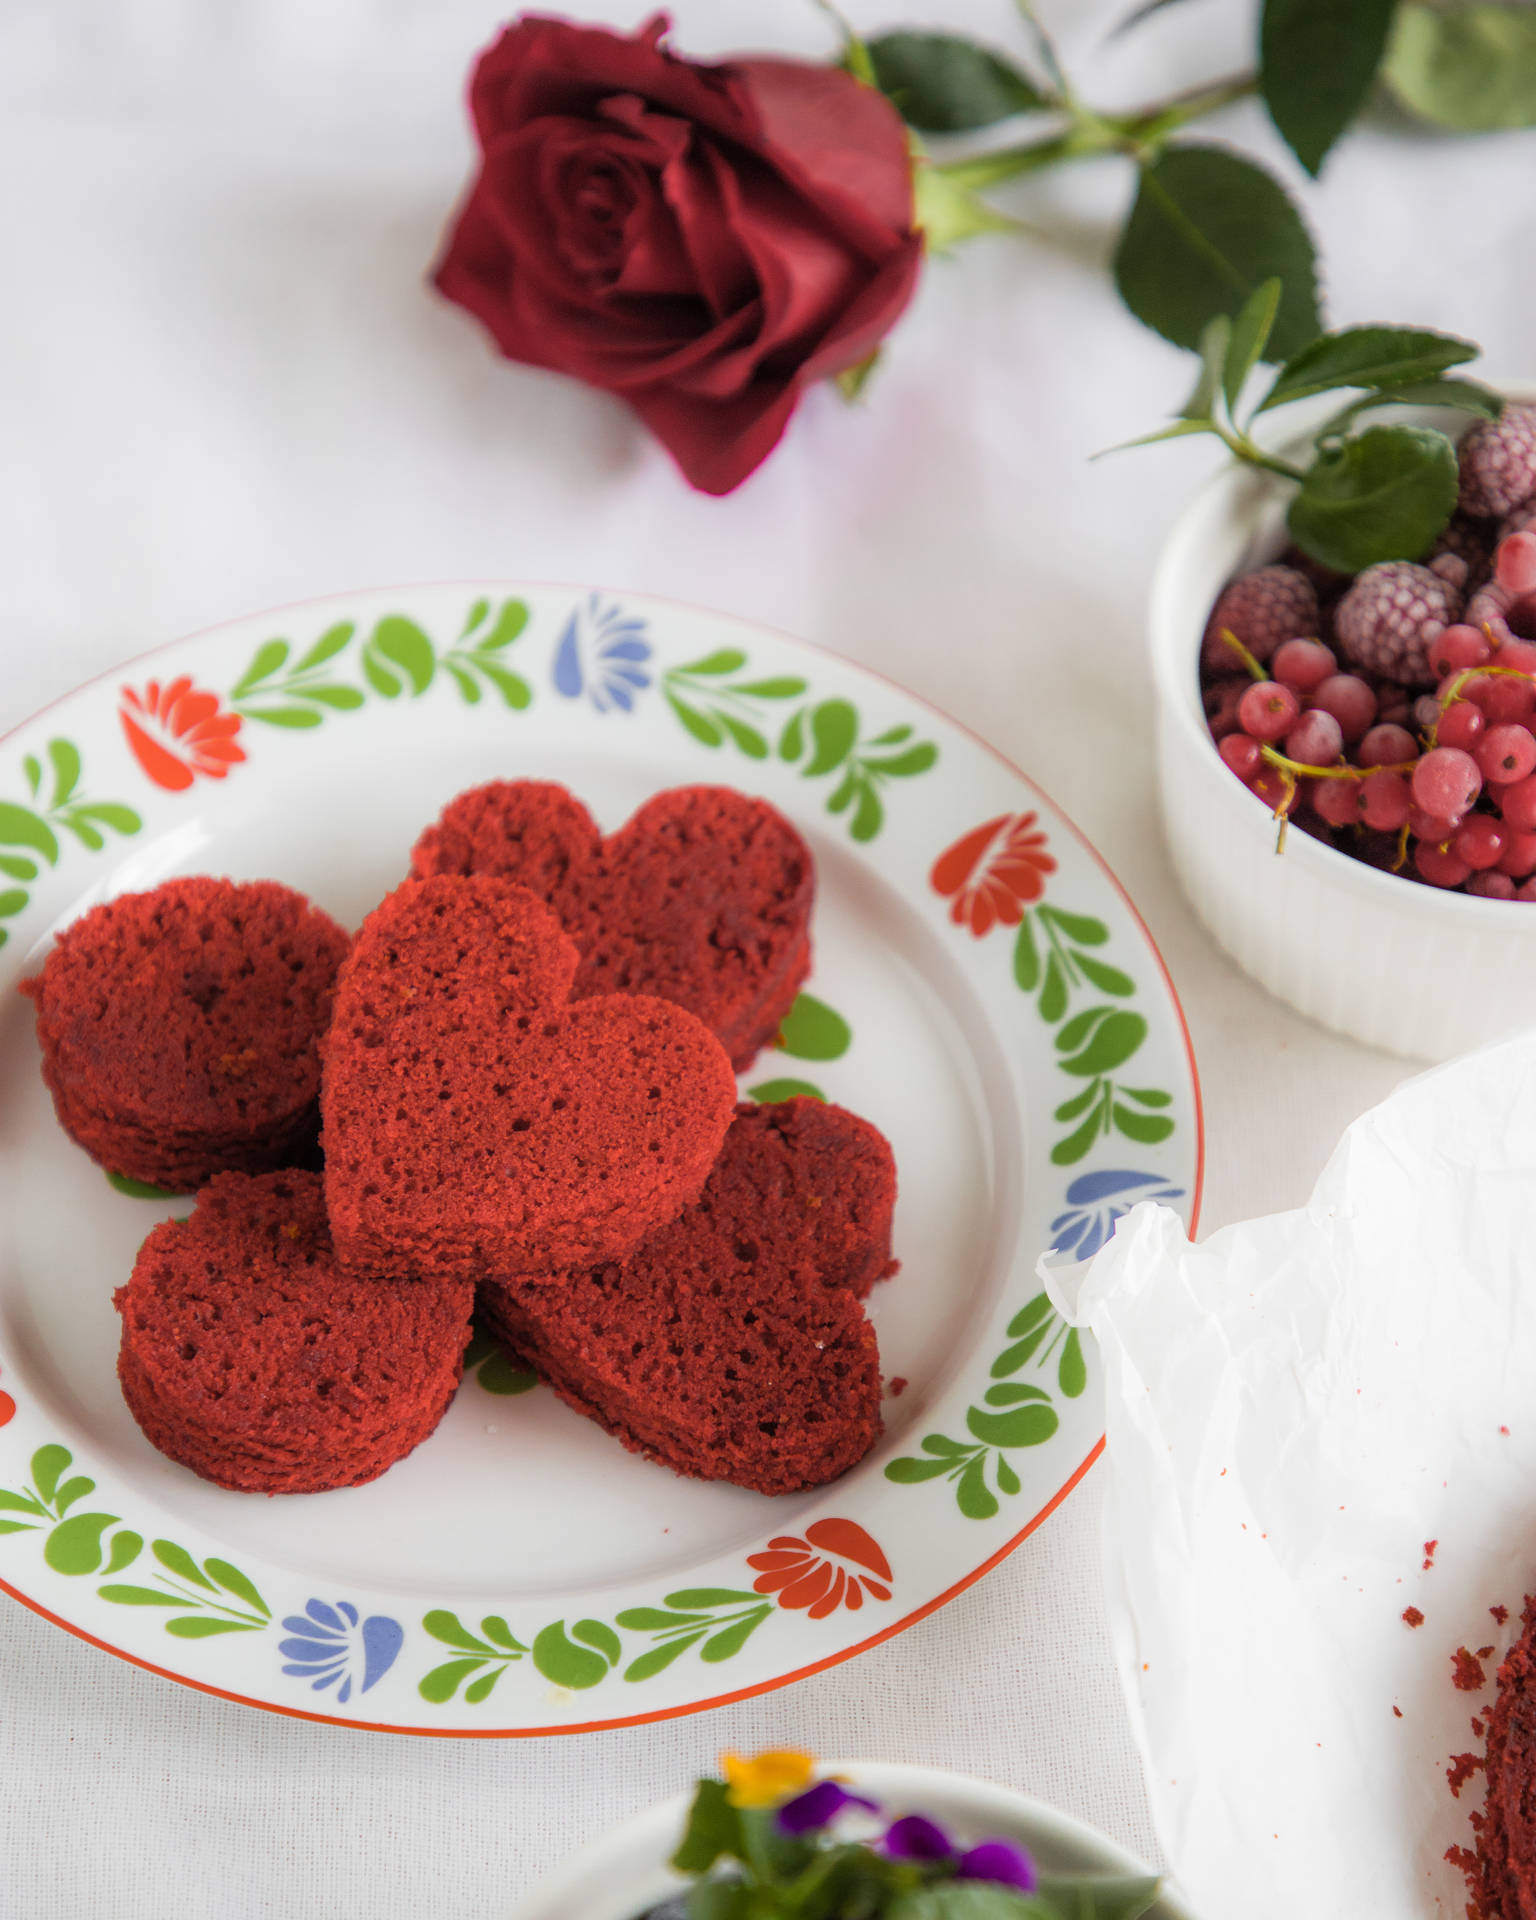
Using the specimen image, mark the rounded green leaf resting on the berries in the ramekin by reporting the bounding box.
[1286,426,1457,574]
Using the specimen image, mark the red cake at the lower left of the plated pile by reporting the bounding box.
[115,1173,474,1494]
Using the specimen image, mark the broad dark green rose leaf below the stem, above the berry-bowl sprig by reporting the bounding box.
[1114,146,1323,359]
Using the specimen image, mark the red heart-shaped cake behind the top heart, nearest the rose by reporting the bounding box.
[411,780,816,1071]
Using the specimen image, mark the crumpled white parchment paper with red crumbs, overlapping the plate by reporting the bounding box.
[1043,1036,1536,1920]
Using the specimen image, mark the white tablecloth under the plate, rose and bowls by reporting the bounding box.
[0,0,1536,1920]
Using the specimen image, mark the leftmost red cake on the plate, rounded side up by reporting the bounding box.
[21,879,348,1192]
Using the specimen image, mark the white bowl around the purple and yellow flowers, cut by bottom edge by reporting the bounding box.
[507,1761,1194,1920]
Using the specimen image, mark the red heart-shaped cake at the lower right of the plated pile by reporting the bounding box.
[480,1098,897,1494]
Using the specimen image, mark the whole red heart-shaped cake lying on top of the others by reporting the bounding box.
[321,874,735,1279]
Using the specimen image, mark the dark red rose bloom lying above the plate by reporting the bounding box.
[426,15,922,493]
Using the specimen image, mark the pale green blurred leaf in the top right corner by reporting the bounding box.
[1382,6,1536,132]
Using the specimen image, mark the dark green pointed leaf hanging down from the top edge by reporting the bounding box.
[1260,0,1396,175]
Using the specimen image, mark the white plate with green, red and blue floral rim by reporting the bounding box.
[0,584,1202,1736]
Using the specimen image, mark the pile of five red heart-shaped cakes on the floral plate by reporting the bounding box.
[25,781,897,1494]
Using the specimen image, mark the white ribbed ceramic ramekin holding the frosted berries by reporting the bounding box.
[1150,382,1536,1060]
